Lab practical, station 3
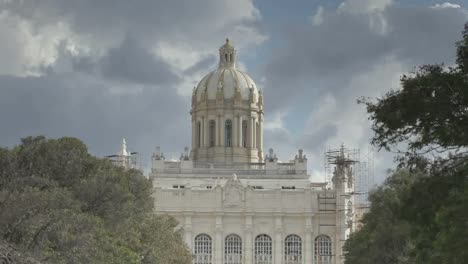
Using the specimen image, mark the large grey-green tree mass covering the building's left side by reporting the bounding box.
[0,137,191,264]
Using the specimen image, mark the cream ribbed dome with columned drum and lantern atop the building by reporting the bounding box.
[191,40,263,163]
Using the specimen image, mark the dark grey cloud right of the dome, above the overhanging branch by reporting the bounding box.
[264,6,467,109]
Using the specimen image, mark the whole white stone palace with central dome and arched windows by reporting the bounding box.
[150,40,354,264]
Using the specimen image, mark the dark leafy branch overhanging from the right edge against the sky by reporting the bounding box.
[358,24,468,165]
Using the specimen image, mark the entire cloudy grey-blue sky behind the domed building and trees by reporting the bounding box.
[0,0,468,184]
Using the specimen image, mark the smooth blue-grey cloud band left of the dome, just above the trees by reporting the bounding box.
[0,73,190,157]
